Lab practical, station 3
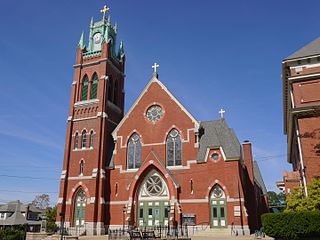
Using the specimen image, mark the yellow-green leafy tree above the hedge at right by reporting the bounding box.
[286,178,320,212]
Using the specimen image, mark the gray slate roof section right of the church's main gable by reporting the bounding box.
[197,119,241,162]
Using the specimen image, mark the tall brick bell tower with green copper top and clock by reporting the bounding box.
[57,6,125,235]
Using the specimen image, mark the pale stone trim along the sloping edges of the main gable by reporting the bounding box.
[112,76,199,140]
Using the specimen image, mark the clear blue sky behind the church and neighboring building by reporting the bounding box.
[0,0,320,204]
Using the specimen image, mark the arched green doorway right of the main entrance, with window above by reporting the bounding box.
[210,184,228,228]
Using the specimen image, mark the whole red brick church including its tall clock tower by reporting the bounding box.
[57,7,267,235]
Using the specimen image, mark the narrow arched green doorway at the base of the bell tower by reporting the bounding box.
[74,189,87,227]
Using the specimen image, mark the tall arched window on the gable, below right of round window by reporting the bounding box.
[166,129,182,166]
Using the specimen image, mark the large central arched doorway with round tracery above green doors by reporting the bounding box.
[137,171,170,227]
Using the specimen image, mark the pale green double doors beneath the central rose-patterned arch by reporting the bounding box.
[138,201,170,227]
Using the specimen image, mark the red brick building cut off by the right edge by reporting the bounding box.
[282,38,320,194]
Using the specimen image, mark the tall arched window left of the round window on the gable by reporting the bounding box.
[127,133,141,169]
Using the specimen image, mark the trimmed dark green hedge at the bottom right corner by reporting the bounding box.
[261,211,320,240]
